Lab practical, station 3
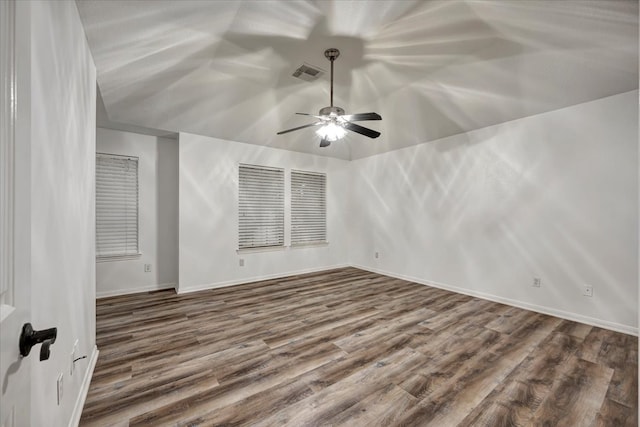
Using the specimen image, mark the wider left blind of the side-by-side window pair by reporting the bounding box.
[238,164,284,249]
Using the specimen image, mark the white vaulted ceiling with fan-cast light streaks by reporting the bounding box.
[77,0,638,159]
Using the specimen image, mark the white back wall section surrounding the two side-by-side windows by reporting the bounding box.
[178,133,349,292]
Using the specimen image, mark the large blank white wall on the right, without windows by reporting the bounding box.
[349,91,638,333]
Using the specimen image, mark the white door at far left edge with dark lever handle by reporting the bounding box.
[0,0,31,427]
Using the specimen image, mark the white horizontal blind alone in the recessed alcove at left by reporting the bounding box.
[96,153,138,257]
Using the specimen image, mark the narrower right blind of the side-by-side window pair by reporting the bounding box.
[291,171,327,245]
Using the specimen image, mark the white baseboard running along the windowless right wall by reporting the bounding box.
[351,264,638,336]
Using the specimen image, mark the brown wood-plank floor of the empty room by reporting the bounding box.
[80,268,638,427]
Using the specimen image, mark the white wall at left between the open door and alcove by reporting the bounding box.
[28,1,97,427]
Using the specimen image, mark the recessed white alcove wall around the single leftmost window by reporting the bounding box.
[96,128,178,297]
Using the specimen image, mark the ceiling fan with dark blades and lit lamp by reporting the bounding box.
[278,48,382,147]
